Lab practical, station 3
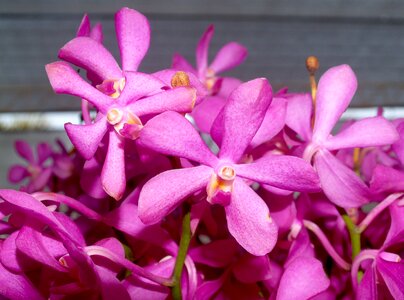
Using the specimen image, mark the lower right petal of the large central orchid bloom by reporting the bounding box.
[225,177,278,256]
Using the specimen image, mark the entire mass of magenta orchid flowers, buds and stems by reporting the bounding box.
[0,8,404,300]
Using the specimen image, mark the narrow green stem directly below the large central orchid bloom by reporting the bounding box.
[171,205,192,300]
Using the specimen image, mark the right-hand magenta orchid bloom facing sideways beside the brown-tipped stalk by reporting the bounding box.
[286,65,398,208]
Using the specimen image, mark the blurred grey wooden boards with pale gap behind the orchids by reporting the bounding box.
[0,0,404,187]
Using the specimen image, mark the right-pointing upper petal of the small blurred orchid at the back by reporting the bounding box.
[209,42,248,73]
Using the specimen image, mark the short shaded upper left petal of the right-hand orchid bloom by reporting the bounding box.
[285,94,313,141]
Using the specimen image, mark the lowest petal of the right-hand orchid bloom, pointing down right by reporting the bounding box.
[314,150,370,208]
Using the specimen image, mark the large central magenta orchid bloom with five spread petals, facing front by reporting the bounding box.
[139,79,319,255]
